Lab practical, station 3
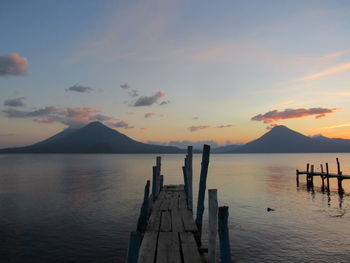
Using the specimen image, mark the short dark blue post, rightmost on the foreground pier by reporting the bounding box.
[218,206,231,263]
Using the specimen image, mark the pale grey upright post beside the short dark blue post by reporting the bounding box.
[208,189,218,263]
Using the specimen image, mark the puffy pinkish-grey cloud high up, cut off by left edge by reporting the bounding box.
[0,53,28,76]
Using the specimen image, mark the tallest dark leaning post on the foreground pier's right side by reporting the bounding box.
[196,144,210,241]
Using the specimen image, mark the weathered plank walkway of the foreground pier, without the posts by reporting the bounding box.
[138,185,202,263]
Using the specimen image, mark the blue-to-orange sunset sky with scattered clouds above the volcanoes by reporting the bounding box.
[0,0,350,147]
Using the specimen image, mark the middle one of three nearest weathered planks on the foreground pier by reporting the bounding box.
[156,232,181,263]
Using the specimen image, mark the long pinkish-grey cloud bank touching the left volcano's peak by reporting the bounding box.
[3,106,116,128]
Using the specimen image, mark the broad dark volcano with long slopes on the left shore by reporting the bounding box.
[0,122,184,153]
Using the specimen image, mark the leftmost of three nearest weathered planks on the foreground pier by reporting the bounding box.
[138,232,158,263]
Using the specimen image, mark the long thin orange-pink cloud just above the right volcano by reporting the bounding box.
[251,107,337,123]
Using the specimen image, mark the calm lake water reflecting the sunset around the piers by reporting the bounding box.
[0,154,350,262]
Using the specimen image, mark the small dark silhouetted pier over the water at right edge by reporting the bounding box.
[296,158,350,192]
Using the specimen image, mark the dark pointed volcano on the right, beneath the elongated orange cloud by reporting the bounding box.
[226,126,350,153]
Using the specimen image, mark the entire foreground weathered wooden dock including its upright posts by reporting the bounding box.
[126,145,231,263]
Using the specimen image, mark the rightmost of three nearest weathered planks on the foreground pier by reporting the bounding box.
[180,232,202,263]
